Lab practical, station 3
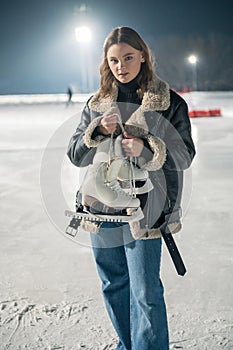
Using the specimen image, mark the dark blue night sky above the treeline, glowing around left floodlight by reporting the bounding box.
[0,0,233,94]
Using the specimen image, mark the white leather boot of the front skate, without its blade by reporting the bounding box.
[81,162,140,209]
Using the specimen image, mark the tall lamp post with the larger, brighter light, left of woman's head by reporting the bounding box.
[75,26,93,92]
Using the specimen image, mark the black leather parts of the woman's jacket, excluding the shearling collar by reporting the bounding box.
[67,85,195,239]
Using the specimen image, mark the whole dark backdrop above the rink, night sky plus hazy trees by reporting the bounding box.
[0,0,233,94]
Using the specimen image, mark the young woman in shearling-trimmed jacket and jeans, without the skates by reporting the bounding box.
[68,27,195,350]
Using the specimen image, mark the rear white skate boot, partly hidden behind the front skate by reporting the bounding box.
[114,135,153,194]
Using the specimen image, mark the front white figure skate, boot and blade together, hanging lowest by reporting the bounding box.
[65,161,144,236]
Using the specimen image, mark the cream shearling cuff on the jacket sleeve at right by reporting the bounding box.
[141,135,166,171]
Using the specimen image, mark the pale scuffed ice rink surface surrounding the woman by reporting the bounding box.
[0,92,233,350]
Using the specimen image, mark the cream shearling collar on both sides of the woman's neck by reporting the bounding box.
[89,75,170,113]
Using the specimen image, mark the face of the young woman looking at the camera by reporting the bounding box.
[107,43,145,83]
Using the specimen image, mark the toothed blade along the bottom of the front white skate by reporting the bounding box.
[65,207,144,222]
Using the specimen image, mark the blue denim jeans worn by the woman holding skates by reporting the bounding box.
[91,224,169,350]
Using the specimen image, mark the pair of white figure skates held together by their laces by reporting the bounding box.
[65,130,153,236]
